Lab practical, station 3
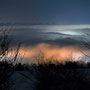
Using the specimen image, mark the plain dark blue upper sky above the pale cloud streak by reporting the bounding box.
[0,0,90,24]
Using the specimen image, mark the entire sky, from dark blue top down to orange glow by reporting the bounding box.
[0,0,90,63]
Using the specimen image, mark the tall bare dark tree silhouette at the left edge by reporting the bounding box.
[0,27,21,90]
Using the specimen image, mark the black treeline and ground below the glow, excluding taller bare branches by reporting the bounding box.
[0,61,90,90]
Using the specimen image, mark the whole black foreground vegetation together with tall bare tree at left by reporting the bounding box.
[0,29,90,90]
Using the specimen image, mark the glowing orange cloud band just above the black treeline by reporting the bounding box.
[8,44,83,63]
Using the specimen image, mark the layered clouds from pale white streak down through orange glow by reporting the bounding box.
[0,25,90,63]
